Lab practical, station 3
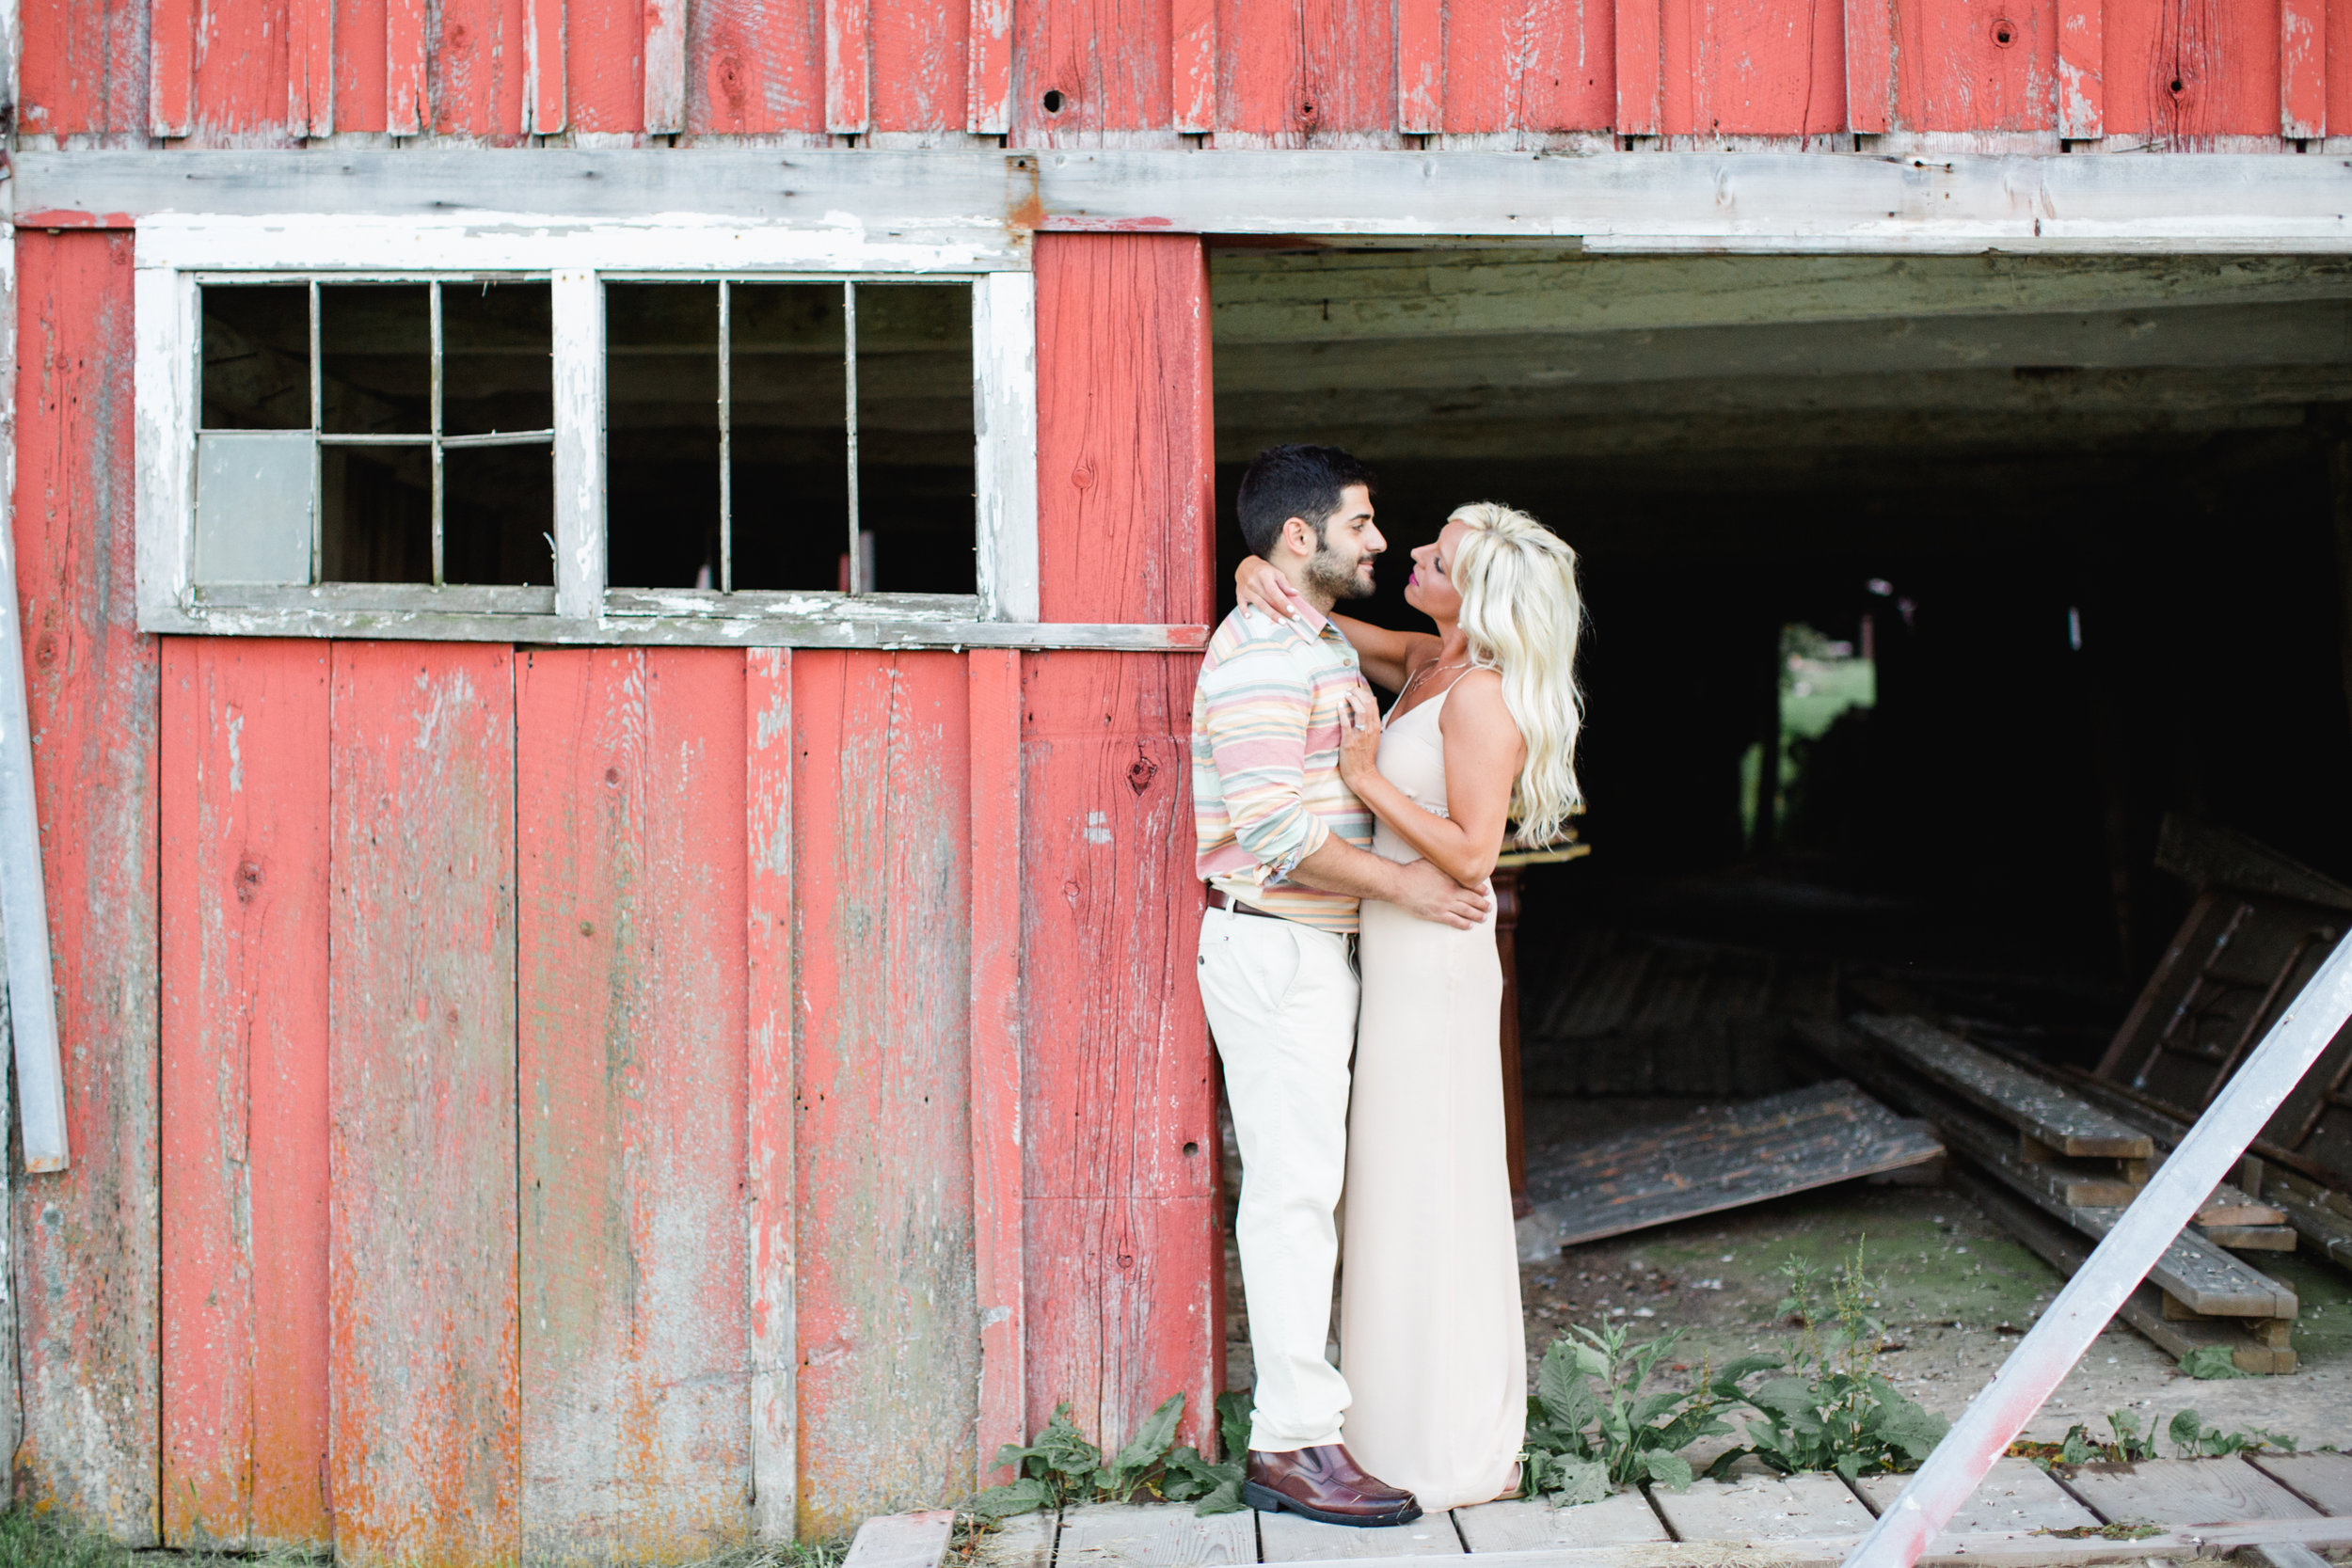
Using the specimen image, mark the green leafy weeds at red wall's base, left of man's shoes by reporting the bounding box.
[969,1394,1249,1523]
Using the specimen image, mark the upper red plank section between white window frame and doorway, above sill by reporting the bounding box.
[1038,235,1216,625]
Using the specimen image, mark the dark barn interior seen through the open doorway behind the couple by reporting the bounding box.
[1212,245,2352,1096]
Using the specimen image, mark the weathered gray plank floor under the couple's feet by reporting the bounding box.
[922,1453,2352,1568]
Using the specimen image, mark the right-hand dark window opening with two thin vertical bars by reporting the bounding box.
[605,279,977,594]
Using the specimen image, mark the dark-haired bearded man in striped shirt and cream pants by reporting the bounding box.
[1193,447,1486,1526]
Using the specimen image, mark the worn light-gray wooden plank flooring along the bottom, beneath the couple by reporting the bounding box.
[941,1453,2352,1568]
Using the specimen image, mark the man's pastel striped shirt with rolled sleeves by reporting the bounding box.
[1193,607,1372,933]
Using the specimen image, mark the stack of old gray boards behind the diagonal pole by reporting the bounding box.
[1804,1013,2298,1373]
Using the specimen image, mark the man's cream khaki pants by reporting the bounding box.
[1200,910,1358,1453]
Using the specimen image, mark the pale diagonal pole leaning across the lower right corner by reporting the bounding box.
[1844,936,2352,1568]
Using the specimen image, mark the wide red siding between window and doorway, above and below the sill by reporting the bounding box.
[1021,235,1223,1441]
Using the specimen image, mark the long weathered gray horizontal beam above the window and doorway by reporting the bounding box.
[17,148,2352,251]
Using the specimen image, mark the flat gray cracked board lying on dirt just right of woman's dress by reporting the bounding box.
[1519,1082,1943,1262]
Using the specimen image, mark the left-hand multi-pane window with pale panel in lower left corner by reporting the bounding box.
[193,279,555,588]
